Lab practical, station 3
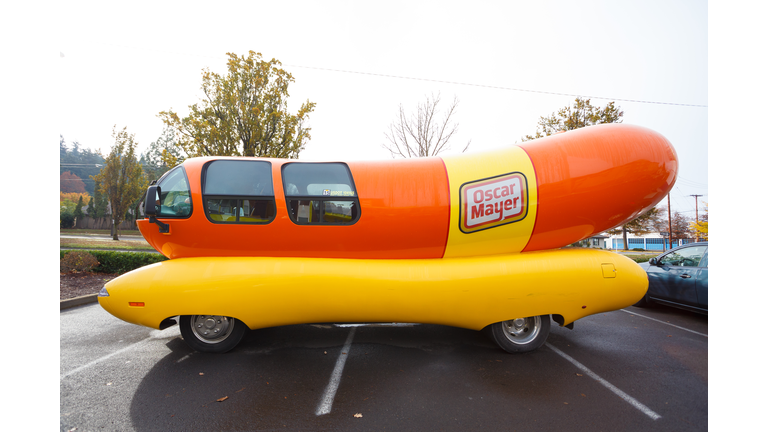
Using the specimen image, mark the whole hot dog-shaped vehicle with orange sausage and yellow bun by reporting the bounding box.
[99,124,678,353]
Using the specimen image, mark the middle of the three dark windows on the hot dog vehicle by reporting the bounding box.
[203,160,275,224]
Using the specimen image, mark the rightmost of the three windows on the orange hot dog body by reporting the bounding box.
[282,162,360,225]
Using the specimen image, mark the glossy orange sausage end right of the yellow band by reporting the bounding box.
[519,124,678,252]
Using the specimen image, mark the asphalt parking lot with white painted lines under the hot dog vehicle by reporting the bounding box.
[59,304,708,431]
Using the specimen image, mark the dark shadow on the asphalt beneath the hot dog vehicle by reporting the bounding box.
[130,325,576,431]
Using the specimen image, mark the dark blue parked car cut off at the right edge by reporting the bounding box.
[635,242,709,314]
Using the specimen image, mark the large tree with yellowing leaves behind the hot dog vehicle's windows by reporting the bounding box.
[158,51,315,166]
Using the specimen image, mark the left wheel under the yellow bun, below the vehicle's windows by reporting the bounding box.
[179,315,248,353]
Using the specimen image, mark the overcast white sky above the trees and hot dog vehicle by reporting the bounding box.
[56,0,708,217]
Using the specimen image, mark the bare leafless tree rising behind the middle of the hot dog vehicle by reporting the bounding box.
[384,93,472,158]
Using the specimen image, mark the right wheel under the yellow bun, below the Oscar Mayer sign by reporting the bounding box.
[491,315,552,354]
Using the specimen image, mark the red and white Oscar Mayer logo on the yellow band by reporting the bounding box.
[459,173,528,234]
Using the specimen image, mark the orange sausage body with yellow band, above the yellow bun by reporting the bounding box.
[138,124,678,259]
